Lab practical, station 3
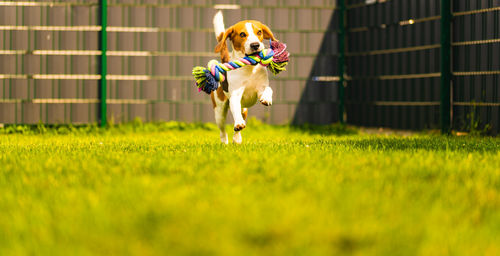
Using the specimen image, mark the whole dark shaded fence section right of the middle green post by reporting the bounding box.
[346,0,500,133]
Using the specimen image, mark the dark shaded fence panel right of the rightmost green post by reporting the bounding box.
[452,0,500,134]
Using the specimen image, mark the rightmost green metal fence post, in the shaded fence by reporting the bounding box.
[440,0,451,134]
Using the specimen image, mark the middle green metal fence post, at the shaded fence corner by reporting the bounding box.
[337,0,346,123]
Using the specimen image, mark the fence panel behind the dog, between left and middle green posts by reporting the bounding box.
[103,1,340,123]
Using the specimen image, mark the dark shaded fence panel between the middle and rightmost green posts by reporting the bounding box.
[346,0,440,129]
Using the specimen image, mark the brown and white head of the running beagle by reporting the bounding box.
[215,20,276,55]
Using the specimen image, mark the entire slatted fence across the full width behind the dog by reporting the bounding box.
[0,0,500,134]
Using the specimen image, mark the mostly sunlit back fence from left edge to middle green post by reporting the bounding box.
[0,0,336,124]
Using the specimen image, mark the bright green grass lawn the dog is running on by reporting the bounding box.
[0,123,500,255]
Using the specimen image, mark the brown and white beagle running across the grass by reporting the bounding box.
[211,11,276,144]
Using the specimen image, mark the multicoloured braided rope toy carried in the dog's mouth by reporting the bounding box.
[193,41,290,94]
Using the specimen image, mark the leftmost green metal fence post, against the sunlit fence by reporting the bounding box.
[99,0,108,127]
